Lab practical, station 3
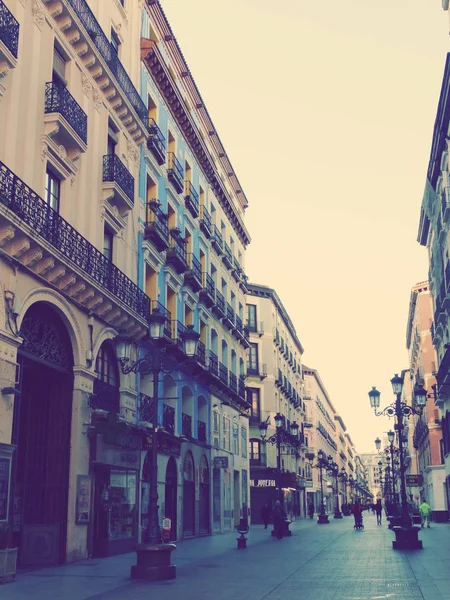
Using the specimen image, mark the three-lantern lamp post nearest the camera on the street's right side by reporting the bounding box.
[369,375,427,549]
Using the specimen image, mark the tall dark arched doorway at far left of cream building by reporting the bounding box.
[12,302,73,565]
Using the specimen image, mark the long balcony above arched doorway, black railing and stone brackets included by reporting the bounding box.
[0,162,150,339]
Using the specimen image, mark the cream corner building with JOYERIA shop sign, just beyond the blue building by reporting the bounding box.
[246,283,306,523]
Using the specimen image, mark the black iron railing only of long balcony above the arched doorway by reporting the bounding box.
[0,161,150,319]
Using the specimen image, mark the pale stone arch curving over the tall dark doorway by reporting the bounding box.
[17,288,86,366]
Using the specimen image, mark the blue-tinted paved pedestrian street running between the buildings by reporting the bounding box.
[0,513,450,600]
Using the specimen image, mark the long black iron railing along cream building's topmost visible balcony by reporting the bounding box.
[68,0,147,123]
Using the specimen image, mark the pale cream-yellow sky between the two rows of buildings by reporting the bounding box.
[162,0,450,453]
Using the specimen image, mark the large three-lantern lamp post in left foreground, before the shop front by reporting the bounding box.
[116,310,200,580]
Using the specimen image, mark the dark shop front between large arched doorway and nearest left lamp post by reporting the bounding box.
[91,414,142,556]
